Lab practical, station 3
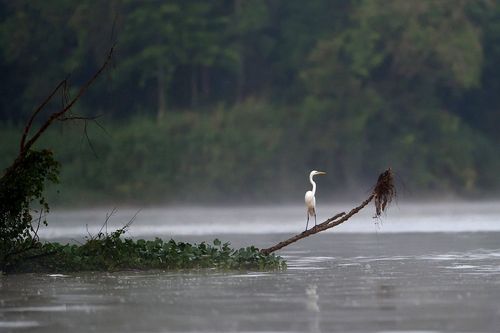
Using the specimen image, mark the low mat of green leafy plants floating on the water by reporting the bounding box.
[9,229,286,273]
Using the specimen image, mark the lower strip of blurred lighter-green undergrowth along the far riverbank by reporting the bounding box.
[0,100,500,206]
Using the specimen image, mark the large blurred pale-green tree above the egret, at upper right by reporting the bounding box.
[302,0,483,188]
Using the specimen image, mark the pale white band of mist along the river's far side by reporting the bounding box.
[40,201,500,239]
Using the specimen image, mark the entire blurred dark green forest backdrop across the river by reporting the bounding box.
[0,0,500,200]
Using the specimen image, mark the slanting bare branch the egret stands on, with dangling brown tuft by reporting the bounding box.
[261,168,396,254]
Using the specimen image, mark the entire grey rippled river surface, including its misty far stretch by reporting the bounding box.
[0,202,500,332]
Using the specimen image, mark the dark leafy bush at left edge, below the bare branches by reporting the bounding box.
[0,150,59,269]
